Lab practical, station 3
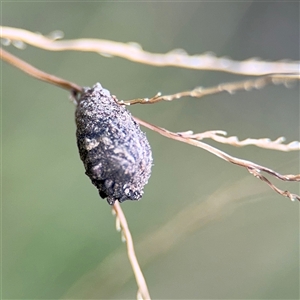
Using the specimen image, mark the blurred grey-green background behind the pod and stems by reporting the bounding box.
[1,1,299,299]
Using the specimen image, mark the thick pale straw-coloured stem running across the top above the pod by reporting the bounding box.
[0,26,299,76]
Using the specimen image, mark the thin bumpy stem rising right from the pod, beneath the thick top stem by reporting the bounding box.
[124,73,300,105]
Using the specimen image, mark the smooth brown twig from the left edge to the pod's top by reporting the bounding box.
[0,48,82,93]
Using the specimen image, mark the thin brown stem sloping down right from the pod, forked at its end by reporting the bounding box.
[135,117,300,201]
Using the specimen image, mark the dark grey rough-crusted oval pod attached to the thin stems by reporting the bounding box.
[75,83,152,205]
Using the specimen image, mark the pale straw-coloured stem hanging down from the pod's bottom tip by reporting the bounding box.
[113,201,150,300]
